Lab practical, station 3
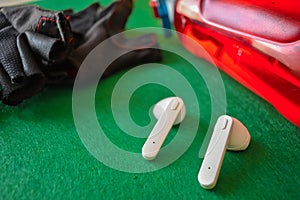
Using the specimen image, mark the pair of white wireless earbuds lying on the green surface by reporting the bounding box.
[142,97,251,189]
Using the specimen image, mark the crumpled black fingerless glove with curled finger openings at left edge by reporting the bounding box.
[0,6,72,105]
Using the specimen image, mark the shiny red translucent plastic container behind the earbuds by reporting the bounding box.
[151,0,300,126]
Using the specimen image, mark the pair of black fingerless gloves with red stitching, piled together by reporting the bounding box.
[0,0,161,105]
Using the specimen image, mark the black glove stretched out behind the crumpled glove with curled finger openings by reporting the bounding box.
[64,0,162,77]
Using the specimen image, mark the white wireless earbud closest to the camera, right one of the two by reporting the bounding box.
[198,115,251,189]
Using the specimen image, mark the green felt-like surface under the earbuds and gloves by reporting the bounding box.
[0,0,300,199]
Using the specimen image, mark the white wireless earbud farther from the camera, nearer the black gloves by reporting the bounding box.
[142,97,186,160]
